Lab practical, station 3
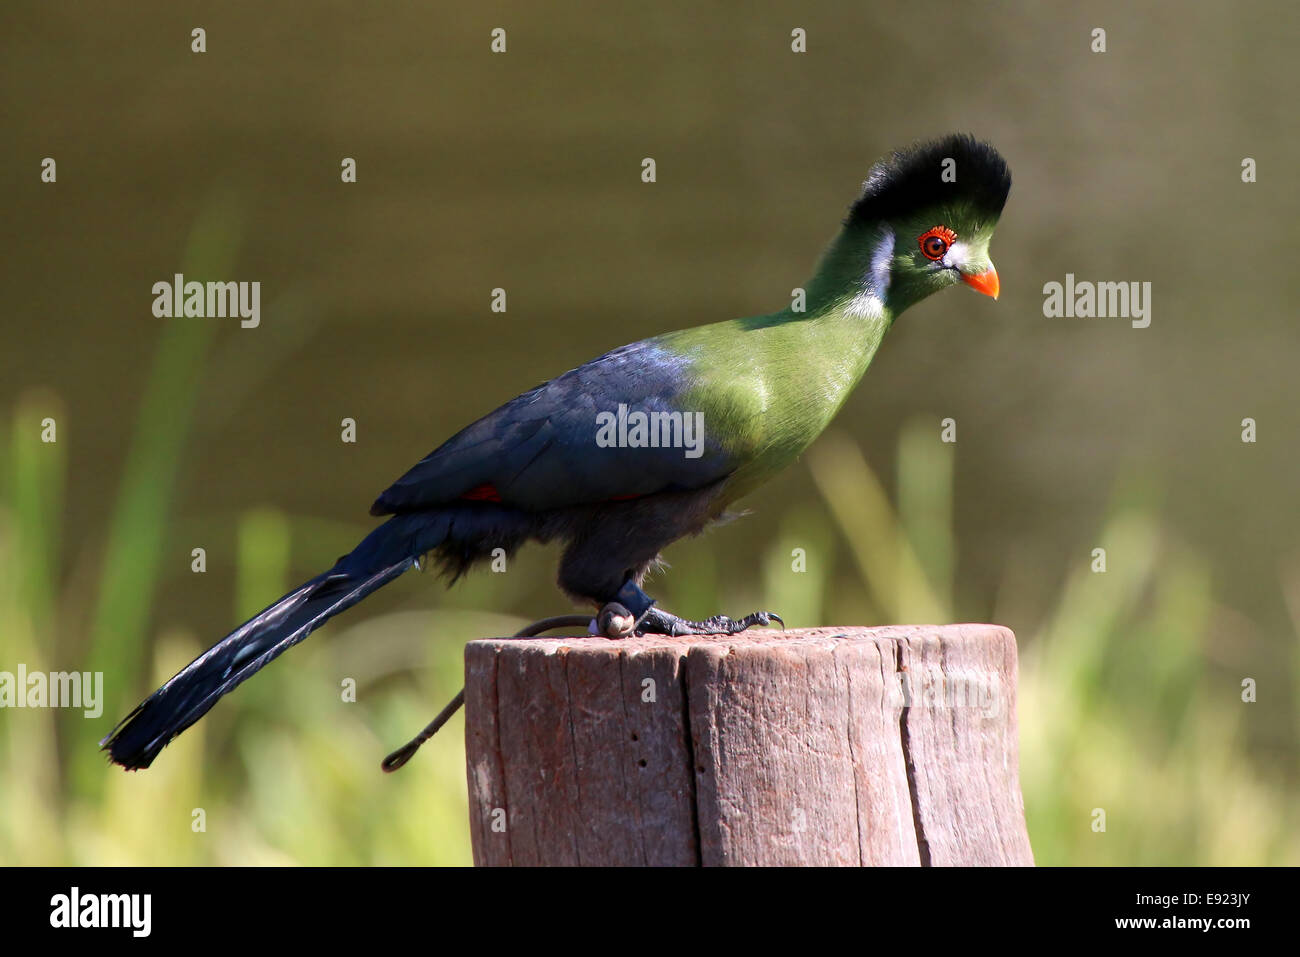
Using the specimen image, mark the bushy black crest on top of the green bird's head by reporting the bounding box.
[845,133,1011,225]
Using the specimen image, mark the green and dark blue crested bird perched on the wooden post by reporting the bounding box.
[100,134,1011,770]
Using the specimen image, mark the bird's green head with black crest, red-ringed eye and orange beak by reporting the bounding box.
[835,134,1011,316]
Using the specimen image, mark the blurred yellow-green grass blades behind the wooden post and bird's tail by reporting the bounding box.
[0,395,1300,865]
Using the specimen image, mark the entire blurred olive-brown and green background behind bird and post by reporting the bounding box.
[0,0,1300,865]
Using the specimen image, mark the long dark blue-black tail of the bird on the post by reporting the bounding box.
[99,515,449,770]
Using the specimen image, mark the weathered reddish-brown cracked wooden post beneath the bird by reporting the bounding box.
[465,624,1034,866]
